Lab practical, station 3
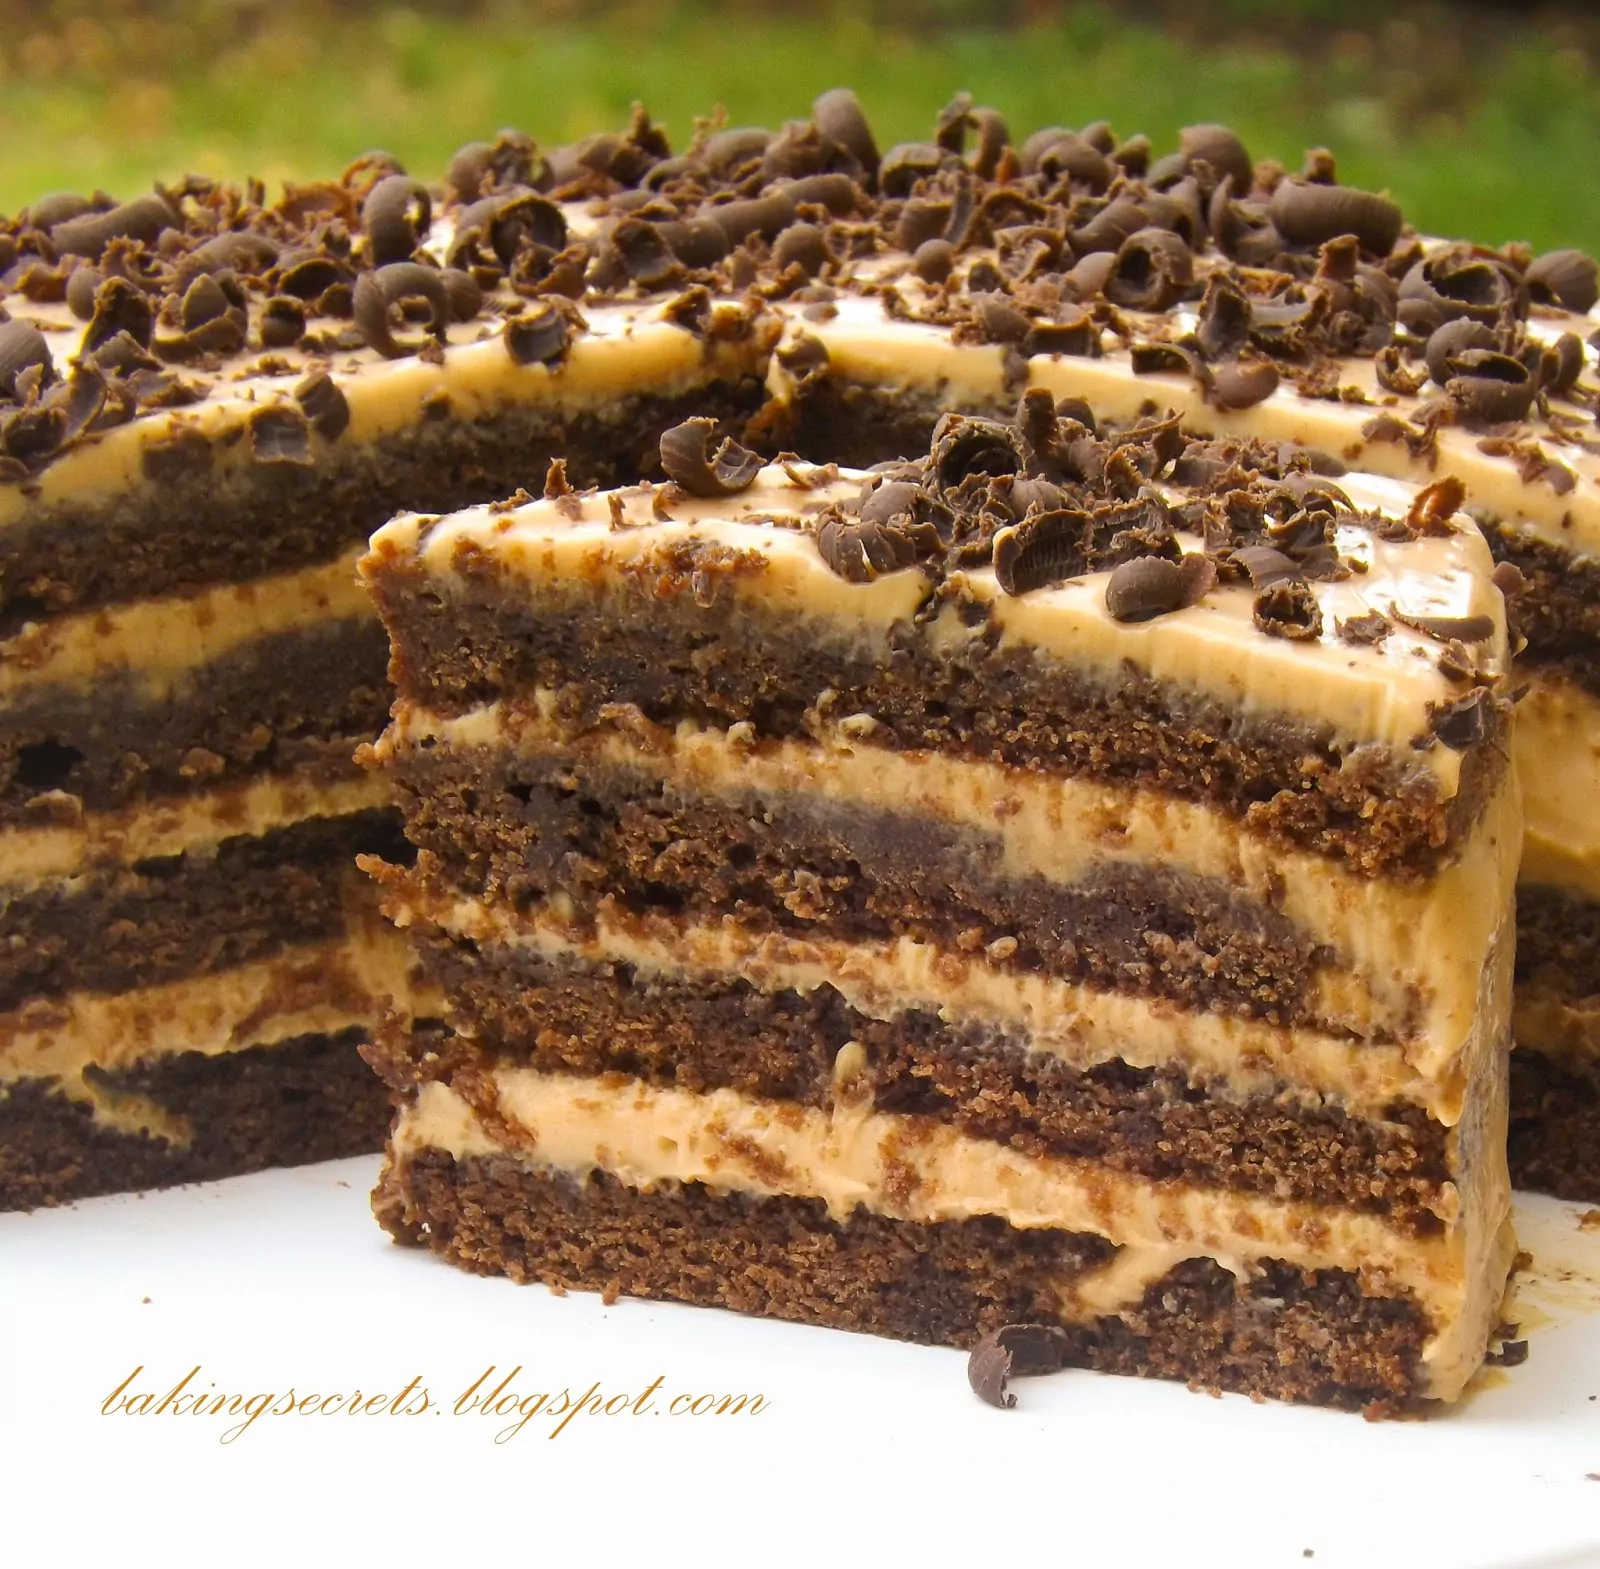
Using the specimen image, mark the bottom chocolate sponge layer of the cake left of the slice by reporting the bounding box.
[0,1030,390,1209]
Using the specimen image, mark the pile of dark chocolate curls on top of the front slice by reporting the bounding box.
[806,398,1465,645]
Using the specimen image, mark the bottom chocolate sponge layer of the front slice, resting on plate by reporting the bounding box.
[373,1150,1429,1415]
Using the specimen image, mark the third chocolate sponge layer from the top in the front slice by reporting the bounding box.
[380,926,1450,1233]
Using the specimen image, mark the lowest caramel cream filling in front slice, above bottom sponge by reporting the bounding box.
[394,1068,1510,1399]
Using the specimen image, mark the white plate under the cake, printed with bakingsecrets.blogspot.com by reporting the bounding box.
[0,1160,1600,1569]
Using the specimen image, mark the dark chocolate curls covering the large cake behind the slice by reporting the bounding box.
[0,90,1600,485]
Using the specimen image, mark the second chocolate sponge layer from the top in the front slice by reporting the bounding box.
[395,749,1330,1024]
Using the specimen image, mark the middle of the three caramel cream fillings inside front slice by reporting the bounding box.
[384,876,1512,1128]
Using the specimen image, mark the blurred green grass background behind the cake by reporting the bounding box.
[0,0,1600,250]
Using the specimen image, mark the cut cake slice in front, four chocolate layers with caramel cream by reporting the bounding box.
[362,395,1522,1412]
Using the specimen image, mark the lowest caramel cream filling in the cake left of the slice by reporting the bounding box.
[0,915,434,1139]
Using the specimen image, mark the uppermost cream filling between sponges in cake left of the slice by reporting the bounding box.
[0,549,373,702]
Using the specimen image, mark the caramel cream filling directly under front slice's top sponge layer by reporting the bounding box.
[387,691,1522,1076]
